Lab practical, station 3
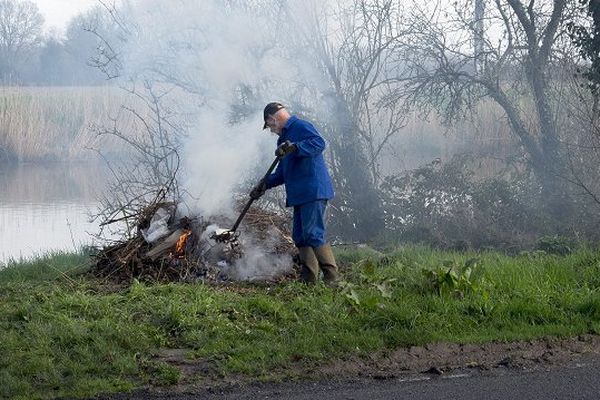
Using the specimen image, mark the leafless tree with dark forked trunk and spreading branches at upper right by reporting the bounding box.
[396,0,573,216]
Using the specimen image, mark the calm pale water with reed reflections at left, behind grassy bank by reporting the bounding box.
[0,163,107,263]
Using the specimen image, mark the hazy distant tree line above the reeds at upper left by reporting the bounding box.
[0,0,110,86]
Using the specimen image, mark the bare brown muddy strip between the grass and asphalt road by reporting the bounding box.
[86,335,600,400]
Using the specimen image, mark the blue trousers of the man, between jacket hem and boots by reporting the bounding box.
[292,200,327,247]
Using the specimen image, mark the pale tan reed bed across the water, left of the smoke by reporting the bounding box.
[0,87,132,162]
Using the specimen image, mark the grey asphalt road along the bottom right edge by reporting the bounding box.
[101,357,600,400]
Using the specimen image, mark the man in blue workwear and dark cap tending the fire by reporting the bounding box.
[250,102,339,283]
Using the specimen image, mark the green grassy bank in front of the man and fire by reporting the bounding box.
[0,248,600,398]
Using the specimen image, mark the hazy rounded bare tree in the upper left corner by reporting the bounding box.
[0,0,44,81]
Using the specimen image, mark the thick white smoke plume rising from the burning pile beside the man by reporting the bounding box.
[116,0,296,216]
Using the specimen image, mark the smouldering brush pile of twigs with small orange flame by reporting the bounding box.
[92,203,297,282]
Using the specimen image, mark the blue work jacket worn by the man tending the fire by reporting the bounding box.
[267,116,334,207]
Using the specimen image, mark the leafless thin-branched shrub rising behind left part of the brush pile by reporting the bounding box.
[93,81,182,238]
